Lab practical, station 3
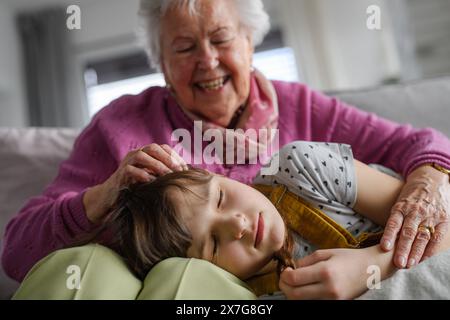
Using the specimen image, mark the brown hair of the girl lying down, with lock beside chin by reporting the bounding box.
[84,168,293,280]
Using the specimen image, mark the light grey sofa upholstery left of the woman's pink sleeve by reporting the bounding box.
[0,128,79,299]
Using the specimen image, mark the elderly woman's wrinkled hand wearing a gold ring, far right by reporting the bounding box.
[381,166,450,268]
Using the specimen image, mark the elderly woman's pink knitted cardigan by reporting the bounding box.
[2,82,450,281]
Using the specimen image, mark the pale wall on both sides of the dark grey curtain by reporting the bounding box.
[0,0,139,127]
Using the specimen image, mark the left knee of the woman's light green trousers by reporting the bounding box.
[13,244,142,300]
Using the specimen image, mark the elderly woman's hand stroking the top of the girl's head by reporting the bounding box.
[83,143,188,222]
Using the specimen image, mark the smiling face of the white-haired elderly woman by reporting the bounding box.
[161,0,253,126]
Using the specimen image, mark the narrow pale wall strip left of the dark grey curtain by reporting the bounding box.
[0,2,28,127]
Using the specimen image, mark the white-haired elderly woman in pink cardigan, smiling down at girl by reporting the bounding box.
[2,0,450,298]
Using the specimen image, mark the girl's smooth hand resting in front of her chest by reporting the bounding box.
[279,249,371,300]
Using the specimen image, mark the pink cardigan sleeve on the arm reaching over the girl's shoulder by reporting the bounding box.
[310,91,450,177]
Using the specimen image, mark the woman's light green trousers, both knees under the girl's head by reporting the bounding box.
[13,244,256,300]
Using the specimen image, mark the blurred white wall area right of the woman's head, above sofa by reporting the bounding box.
[279,0,400,90]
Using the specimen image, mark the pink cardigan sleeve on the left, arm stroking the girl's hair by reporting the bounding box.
[2,114,115,281]
